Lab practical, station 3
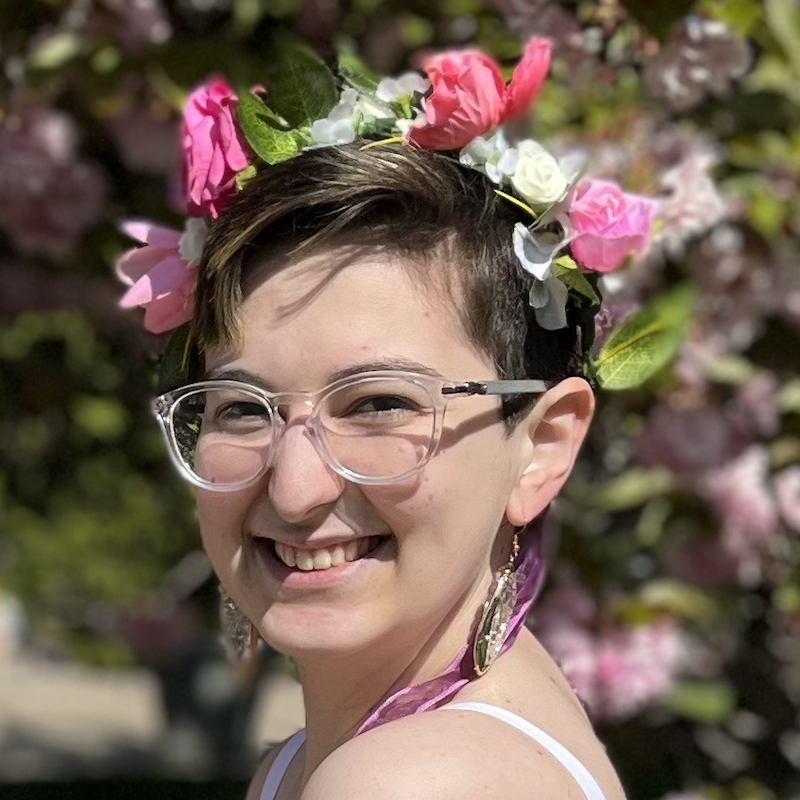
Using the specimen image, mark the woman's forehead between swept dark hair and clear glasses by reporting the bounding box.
[207,248,491,382]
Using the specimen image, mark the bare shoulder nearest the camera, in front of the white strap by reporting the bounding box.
[301,710,612,800]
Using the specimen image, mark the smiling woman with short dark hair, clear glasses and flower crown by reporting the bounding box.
[122,36,650,800]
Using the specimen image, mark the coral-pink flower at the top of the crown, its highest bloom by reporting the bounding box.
[408,39,550,150]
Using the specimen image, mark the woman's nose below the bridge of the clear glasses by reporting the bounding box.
[267,420,345,524]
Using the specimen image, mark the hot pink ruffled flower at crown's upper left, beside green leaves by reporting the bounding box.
[183,78,253,219]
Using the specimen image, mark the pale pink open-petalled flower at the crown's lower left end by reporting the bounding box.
[116,222,197,333]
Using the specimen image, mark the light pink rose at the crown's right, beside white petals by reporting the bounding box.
[568,181,657,272]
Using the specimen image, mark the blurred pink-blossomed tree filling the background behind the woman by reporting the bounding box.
[0,0,800,800]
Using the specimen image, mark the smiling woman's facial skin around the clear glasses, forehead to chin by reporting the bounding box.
[197,251,536,657]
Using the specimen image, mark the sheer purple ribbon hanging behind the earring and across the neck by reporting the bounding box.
[356,512,550,736]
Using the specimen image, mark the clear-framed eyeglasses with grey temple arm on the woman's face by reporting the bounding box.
[153,370,549,492]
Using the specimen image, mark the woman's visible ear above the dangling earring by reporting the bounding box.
[506,378,594,527]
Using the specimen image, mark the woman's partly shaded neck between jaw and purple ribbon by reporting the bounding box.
[290,579,490,787]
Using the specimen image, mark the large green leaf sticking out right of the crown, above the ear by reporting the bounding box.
[595,284,695,391]
